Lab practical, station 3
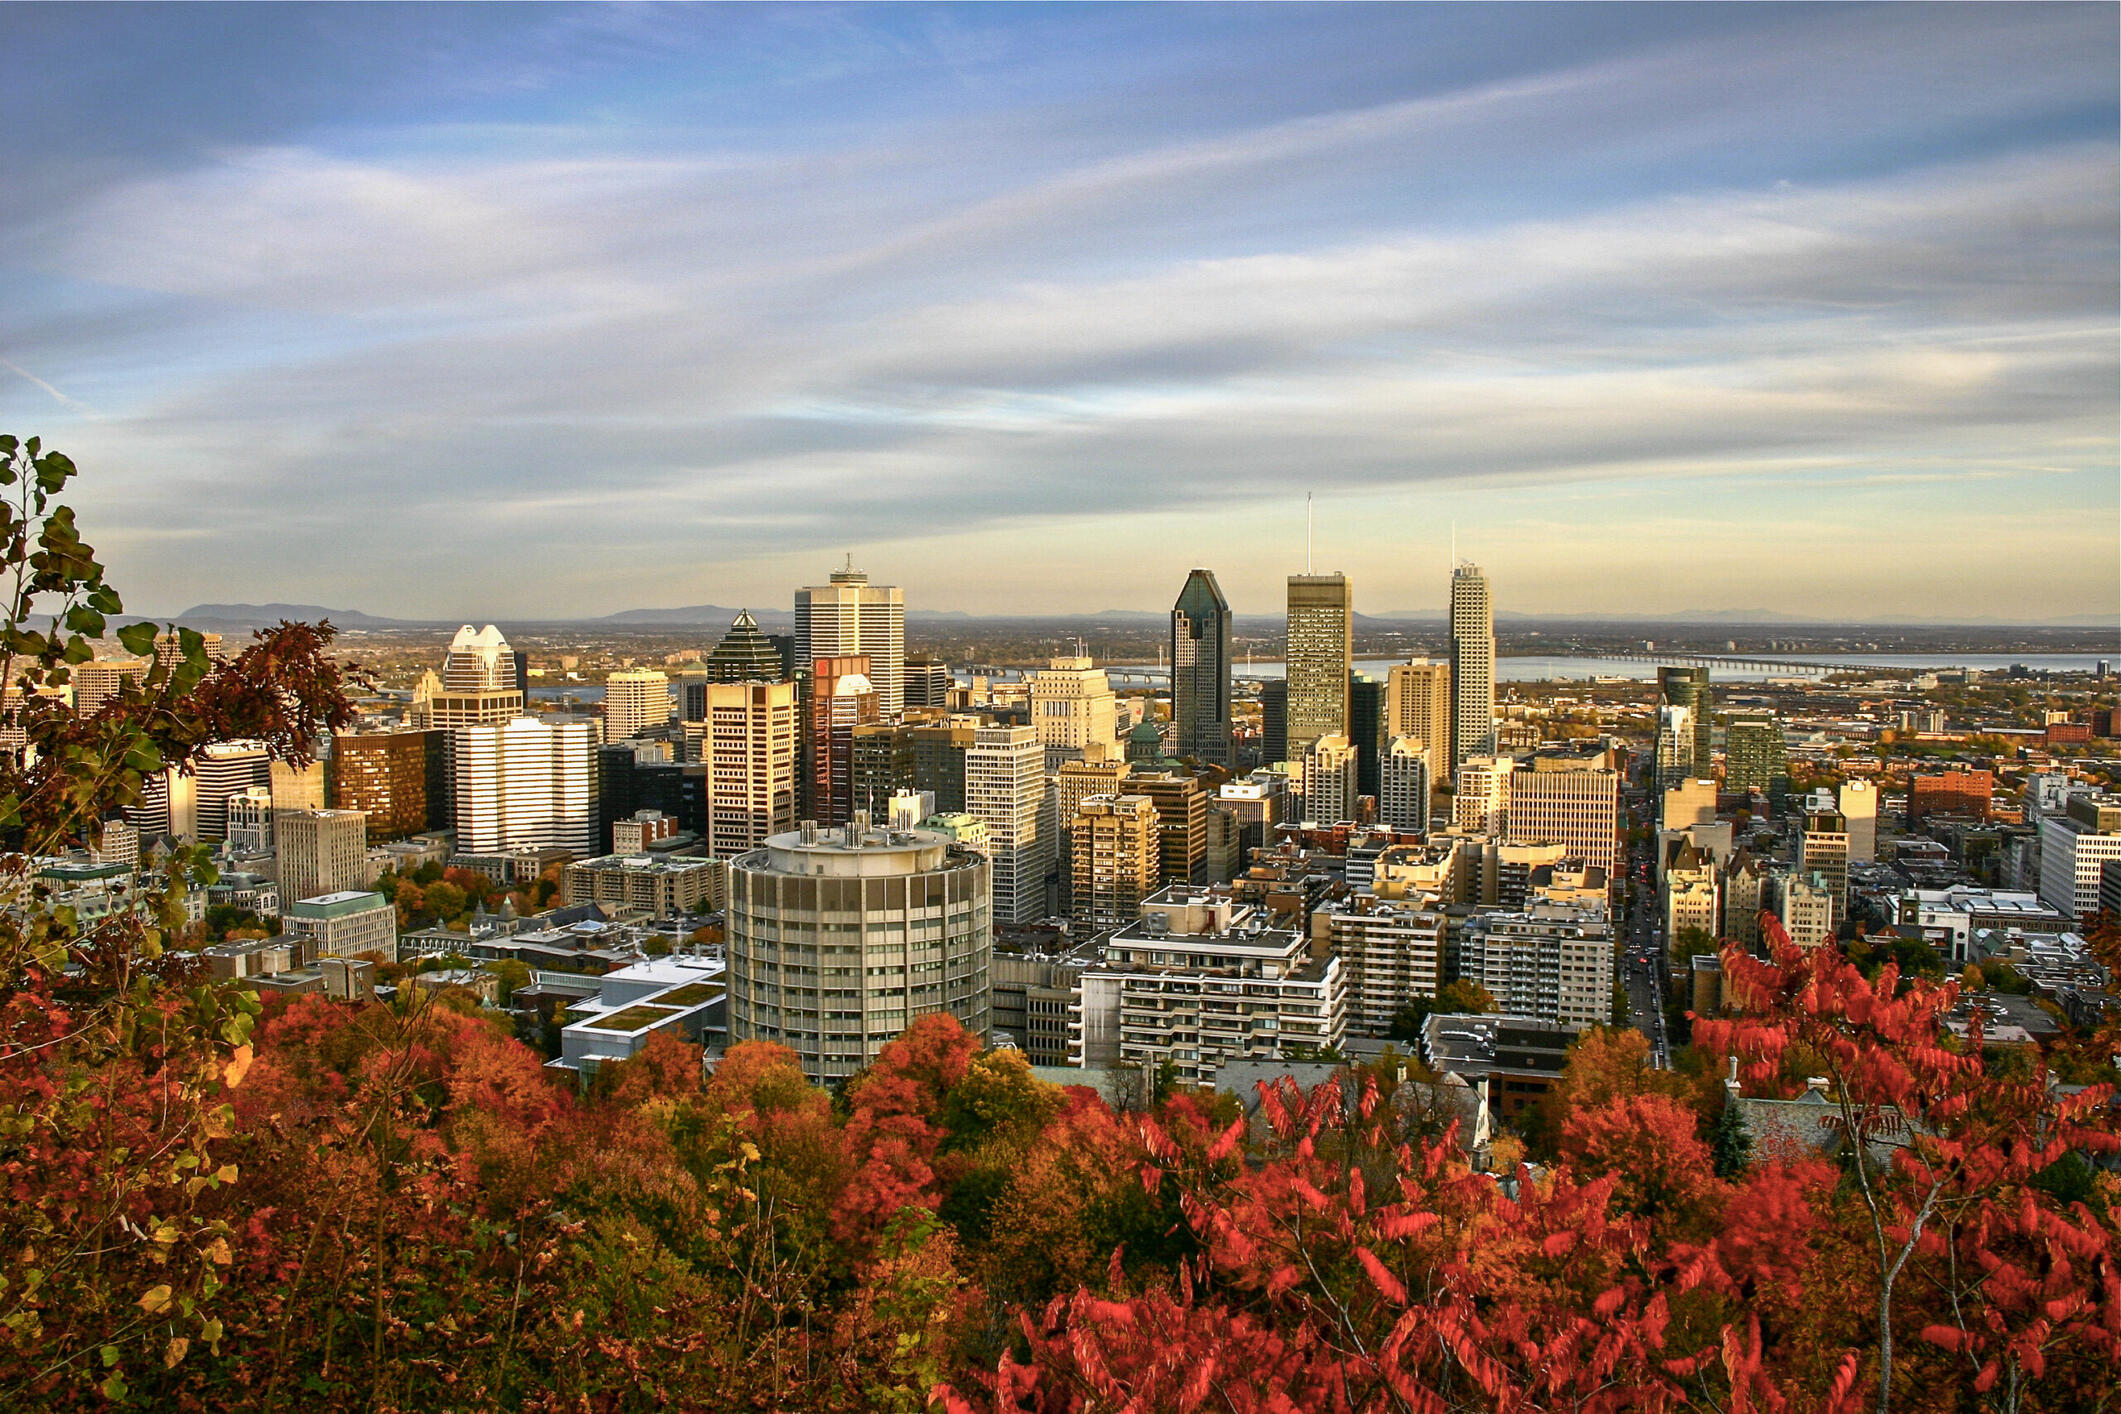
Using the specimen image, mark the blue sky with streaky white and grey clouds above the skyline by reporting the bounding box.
[0,4,2121,621]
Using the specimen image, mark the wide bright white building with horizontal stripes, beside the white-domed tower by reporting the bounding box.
[450,717,602,859]
